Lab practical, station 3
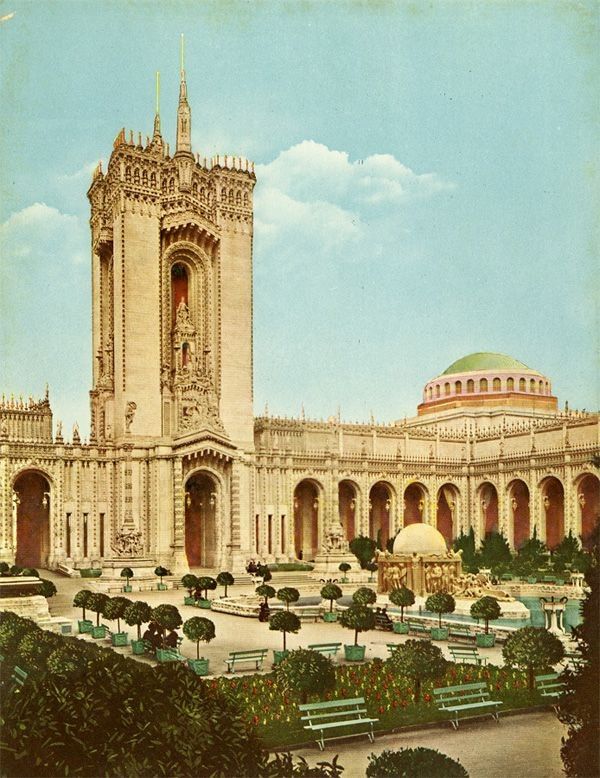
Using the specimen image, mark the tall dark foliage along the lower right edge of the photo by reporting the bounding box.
[558,525,600,778]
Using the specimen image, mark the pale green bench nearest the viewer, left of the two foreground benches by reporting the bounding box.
[298,697,379,751]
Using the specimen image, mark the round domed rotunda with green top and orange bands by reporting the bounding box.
[417,351,558,416]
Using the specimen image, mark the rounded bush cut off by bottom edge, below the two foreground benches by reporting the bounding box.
[366,747,469,778]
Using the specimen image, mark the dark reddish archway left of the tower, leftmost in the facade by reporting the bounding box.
[13,470,52,567]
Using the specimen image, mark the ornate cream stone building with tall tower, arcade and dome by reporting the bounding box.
[0,70,600,573]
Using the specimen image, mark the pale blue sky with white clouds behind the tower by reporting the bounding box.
[0,0,600,432]
